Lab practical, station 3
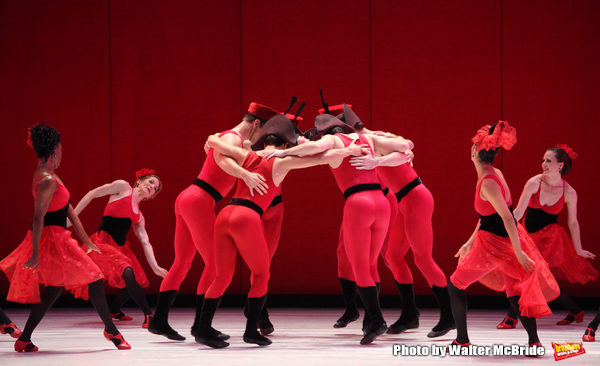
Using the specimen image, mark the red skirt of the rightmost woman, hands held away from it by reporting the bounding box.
[529,224,598,283]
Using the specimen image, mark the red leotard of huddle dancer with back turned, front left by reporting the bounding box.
[206,151,279,299]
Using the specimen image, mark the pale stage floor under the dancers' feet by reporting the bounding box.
[0,308,600,366]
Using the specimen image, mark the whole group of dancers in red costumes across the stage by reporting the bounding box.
[0,94,600,352]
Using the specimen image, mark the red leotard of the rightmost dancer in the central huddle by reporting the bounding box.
[377,164,447,287]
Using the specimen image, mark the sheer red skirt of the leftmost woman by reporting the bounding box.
[0,226,104,303]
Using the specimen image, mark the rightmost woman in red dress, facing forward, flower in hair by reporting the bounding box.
[497,145,598,329]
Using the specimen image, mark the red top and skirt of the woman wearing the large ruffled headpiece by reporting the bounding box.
[450,174,560,318]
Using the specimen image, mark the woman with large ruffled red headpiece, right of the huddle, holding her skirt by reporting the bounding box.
[448,121,559,346]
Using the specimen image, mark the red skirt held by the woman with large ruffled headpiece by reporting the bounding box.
[458,224,560,318]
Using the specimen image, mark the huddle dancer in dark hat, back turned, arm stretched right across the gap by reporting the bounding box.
[196,115,361,348]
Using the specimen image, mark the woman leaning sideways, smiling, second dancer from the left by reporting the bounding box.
[73,169,167,328]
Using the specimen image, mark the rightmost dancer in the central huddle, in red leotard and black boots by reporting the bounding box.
[338,104,455,338]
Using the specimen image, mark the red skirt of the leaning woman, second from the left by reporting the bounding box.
[72,230,150,298]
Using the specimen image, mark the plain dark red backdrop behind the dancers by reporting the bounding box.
[0,0,600,296]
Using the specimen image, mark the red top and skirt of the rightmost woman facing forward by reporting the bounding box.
[526,180,598,284]
